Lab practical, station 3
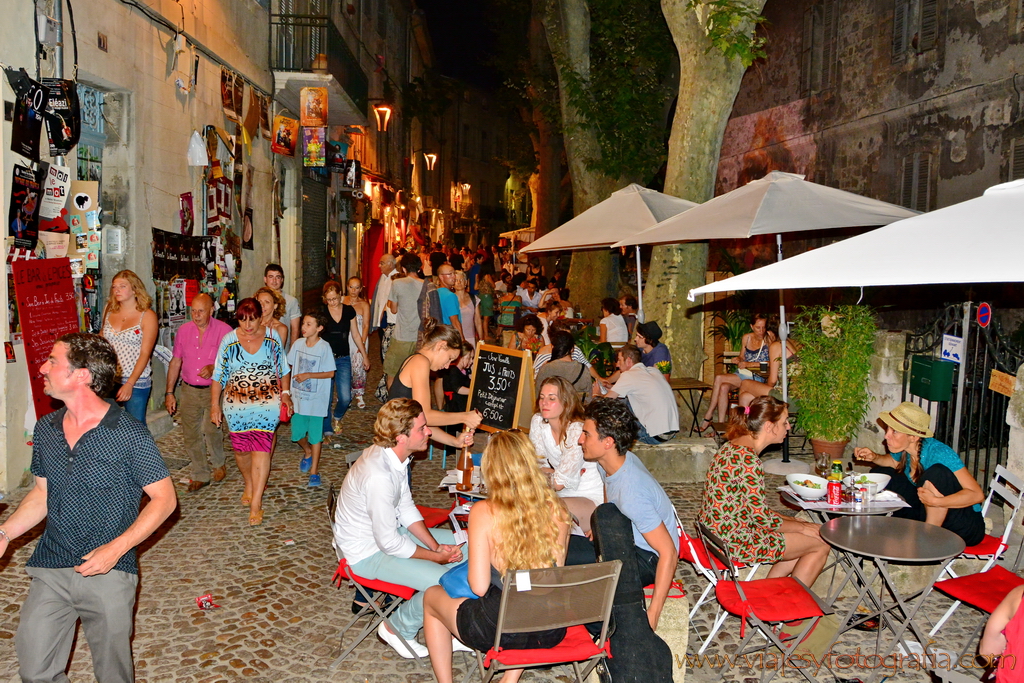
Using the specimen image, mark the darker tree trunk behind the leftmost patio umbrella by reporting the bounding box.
[544,0,631,317]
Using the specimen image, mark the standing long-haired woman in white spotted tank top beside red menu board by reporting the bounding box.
[101,270,157,425]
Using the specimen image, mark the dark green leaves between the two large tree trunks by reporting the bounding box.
[561,0,675,180]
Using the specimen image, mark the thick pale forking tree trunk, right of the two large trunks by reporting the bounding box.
[643,0,765,379]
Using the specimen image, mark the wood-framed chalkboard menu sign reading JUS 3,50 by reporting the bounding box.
[469,344,534,431]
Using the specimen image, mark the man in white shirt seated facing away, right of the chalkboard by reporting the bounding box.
[594,344,679,443]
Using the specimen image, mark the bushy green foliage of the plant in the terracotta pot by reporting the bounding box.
[790,306,877,441]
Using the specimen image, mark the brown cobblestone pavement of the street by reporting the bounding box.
[0,344,1007,683]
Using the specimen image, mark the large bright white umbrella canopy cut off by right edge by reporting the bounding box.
[689,180,1024,301]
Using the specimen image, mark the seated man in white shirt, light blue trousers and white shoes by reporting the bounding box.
[334,398,465,659]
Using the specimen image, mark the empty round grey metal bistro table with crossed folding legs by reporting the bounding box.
[820,516,966,671]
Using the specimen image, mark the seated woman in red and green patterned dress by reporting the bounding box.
[697,396,828,586]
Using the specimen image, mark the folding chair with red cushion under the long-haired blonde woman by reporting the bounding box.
[463,560,623,683]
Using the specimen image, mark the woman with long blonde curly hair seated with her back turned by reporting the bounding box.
[423,431,570,683]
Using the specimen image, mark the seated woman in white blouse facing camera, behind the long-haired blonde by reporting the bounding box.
[529,376,604,531]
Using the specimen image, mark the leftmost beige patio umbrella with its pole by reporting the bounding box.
[520,183,697,323]
